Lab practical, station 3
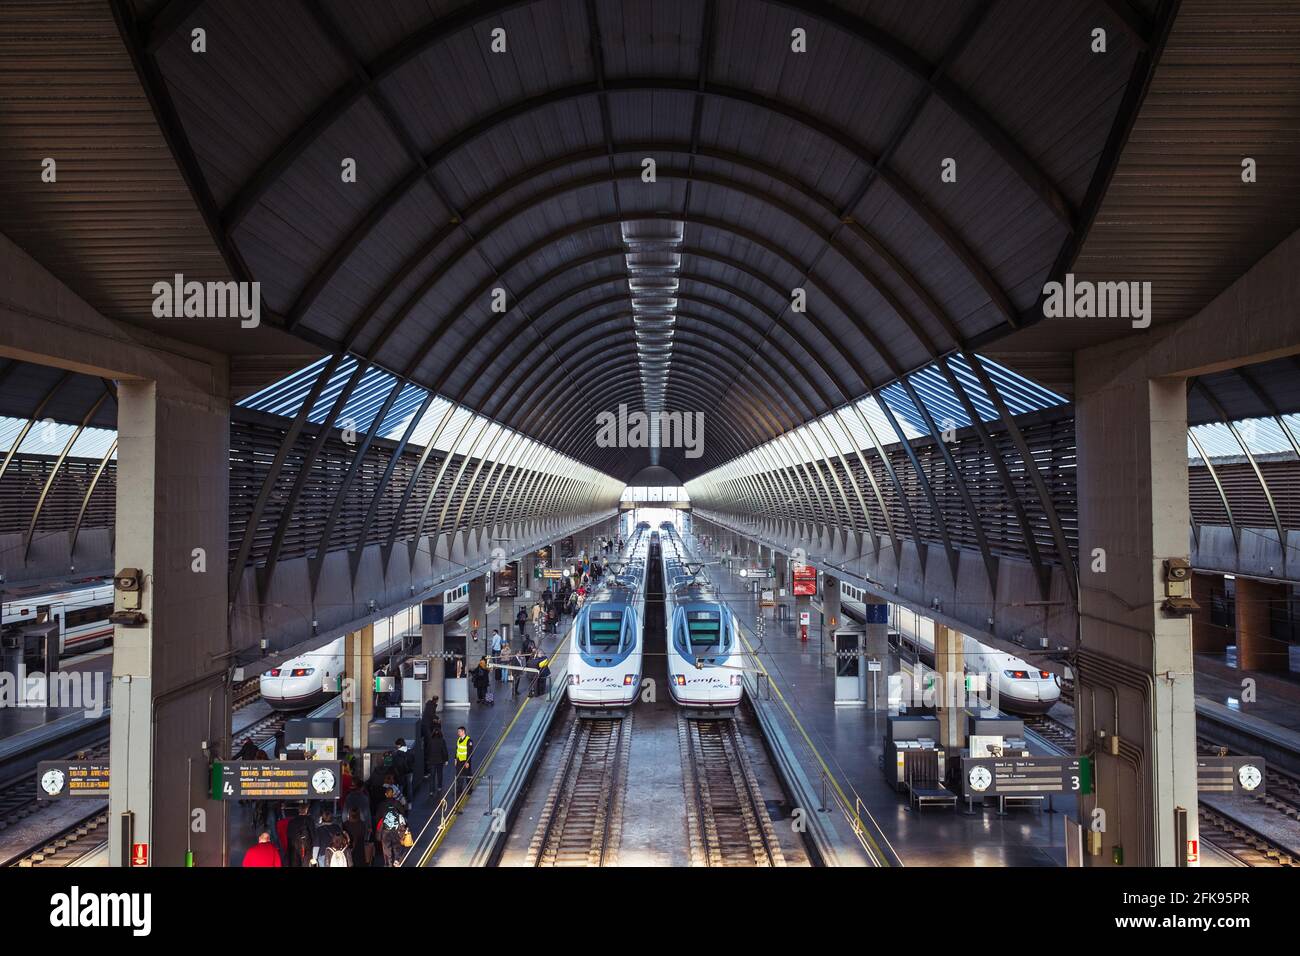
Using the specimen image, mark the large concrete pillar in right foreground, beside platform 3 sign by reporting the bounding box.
[1075,366,1197,866]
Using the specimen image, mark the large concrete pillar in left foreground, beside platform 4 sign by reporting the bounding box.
[108,377,230,866]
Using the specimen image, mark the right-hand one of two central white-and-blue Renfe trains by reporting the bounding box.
[659,522,745,710]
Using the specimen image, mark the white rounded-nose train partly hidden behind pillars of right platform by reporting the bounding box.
[840,583,1061,714]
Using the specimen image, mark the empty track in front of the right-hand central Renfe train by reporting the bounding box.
[677,714,785,866]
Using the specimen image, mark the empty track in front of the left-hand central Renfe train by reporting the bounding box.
[527,714,632,866]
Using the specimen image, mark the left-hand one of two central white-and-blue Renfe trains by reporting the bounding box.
[567,522,644,709]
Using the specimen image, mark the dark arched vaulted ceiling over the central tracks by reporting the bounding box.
[0,0,1177,480]
